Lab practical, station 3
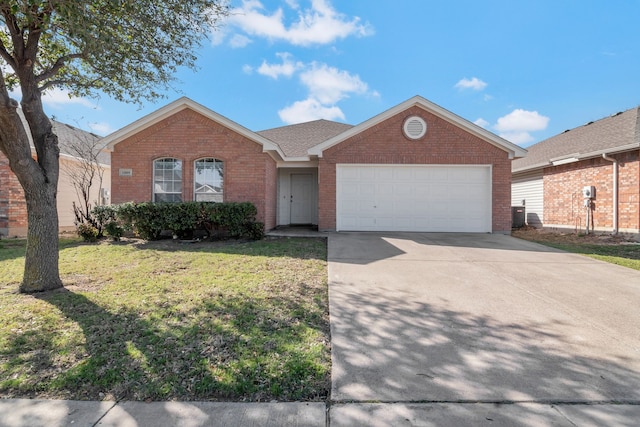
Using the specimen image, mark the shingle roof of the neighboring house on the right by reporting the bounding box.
[512,107,640,172]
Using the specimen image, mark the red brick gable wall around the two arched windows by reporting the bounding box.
[111,110,277,229]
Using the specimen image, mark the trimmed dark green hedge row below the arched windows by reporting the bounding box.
[89,202,264,240]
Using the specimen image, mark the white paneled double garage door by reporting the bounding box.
[336,165,491,232]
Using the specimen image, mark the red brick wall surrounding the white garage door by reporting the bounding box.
[318,107,511,232]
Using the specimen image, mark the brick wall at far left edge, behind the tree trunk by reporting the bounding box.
[0,153,27,236]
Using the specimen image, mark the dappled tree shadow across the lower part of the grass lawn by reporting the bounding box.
[5,288,329,401]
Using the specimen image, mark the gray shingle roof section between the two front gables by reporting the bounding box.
[256,120,353,157]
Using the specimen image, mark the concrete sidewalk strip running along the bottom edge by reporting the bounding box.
[0,399,640,427]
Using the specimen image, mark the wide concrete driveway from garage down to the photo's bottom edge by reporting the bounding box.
[329,233,640,426]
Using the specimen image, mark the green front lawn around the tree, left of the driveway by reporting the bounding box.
[0,238,330,401]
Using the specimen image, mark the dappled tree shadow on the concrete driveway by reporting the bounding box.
[330,282,640,425]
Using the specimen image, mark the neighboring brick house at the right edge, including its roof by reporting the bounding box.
[511,108,640,234]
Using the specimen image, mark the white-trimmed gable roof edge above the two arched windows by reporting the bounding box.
[104,96,284,158]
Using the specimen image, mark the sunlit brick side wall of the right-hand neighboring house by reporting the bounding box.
[544,150,640,233]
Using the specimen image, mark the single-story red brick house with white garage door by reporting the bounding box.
[104,97,526,233]
